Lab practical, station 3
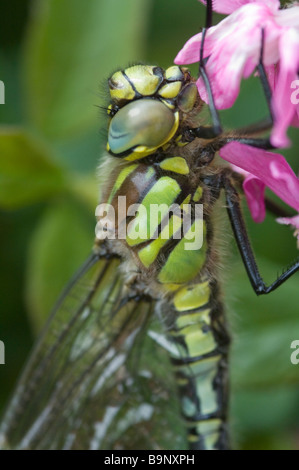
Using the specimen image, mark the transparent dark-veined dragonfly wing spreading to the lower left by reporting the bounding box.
[0,245,186,449]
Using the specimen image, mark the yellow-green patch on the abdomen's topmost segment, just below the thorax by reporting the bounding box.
[173,281,210,312]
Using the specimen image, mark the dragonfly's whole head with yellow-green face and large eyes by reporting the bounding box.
[107,65,198,161]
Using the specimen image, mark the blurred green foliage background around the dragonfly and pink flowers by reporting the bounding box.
[0,0,299,449]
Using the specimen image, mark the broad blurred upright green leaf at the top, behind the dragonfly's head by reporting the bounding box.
[25,0,149,138]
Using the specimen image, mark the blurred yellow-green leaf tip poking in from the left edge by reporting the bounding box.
[0,128,65,209]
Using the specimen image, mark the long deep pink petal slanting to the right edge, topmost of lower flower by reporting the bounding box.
[220,142,299,211]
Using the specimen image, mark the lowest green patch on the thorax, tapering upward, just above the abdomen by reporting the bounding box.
[159,219,207,284]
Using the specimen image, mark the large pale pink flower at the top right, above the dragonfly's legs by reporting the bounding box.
[175,0,299,147]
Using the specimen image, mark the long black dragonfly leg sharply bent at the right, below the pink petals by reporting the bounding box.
[224,178,299,295]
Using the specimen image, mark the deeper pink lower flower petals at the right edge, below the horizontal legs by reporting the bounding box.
[220,142,299,224]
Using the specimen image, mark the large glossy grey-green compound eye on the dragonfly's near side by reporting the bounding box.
[108,99,176,154]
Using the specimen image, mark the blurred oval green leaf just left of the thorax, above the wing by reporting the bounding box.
[26,200,95,331]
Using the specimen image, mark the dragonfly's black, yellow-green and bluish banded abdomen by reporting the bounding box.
[165,280,229,450]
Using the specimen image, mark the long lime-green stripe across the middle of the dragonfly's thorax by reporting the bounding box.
[126,176,181,246]
